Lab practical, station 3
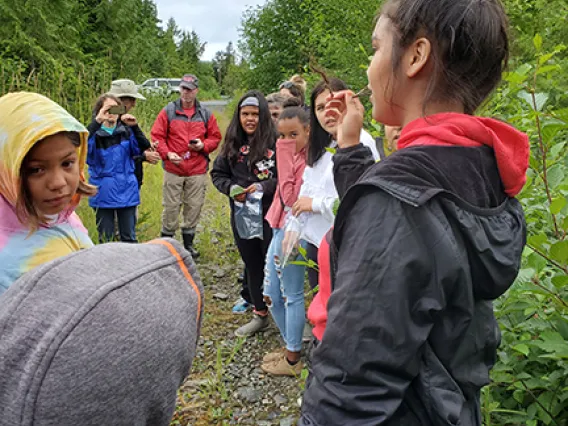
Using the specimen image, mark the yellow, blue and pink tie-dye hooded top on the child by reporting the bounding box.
[0,92,93,295]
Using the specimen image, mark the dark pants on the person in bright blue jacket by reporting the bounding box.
[95,206,137,243]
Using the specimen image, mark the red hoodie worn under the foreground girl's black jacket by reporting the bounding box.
[308,113,530,340]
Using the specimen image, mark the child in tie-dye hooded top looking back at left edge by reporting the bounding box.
[0,92,96,295]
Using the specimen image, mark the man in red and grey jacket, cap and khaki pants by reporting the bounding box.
[151,74,221,258]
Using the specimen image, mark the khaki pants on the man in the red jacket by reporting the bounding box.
[162,170,207,235]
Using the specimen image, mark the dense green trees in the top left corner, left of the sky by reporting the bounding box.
[0,0,219,103]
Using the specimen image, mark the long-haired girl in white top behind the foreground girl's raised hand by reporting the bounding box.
[292,78,379,288]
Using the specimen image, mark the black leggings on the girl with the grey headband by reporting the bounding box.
[231,214,272,312]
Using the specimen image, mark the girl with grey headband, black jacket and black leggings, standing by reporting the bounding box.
[211,90,276,337]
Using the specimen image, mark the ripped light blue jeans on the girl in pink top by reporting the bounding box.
[264,229,306,352]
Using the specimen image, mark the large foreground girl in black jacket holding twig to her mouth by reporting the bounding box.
[299,0,529,426]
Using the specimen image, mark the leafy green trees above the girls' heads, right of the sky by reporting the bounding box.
[240,0,380,93]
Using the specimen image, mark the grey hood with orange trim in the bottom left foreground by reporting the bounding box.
[0,239,203,426]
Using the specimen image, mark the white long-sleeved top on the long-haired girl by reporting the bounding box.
[299,130,380,247]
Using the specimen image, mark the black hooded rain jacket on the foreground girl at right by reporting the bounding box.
[299,145,526,426]
